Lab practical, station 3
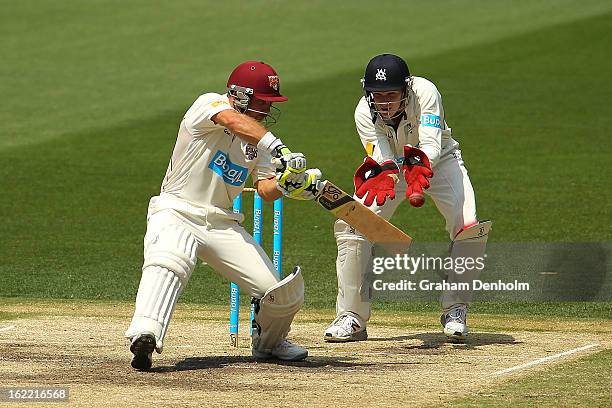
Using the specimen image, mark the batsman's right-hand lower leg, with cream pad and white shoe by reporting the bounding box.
[252,266,308,361]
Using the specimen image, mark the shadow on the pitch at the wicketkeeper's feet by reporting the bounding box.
[368,333,523,350]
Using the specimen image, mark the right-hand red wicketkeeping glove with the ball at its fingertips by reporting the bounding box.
[402,146,433,207]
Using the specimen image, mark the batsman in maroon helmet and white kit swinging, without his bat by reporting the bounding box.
[125,61,321,370]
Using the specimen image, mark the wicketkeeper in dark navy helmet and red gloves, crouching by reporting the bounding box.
[324,54,491,342]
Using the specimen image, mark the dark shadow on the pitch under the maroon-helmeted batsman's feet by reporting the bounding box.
[149,356,373,373]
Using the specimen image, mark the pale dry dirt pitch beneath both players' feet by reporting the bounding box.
[0,302,610,407]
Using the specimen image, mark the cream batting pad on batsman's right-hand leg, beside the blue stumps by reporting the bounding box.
[253,266,304,353]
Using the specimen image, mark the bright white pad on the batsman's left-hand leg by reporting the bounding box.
[125,225,197,353]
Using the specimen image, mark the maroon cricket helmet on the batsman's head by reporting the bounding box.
[227,61,287,102]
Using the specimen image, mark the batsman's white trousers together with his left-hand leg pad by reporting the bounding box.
[126,194,280,352]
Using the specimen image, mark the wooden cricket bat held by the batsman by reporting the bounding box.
[315,180,412,254]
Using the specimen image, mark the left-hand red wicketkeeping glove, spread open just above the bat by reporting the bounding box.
[353,156,399,207]
